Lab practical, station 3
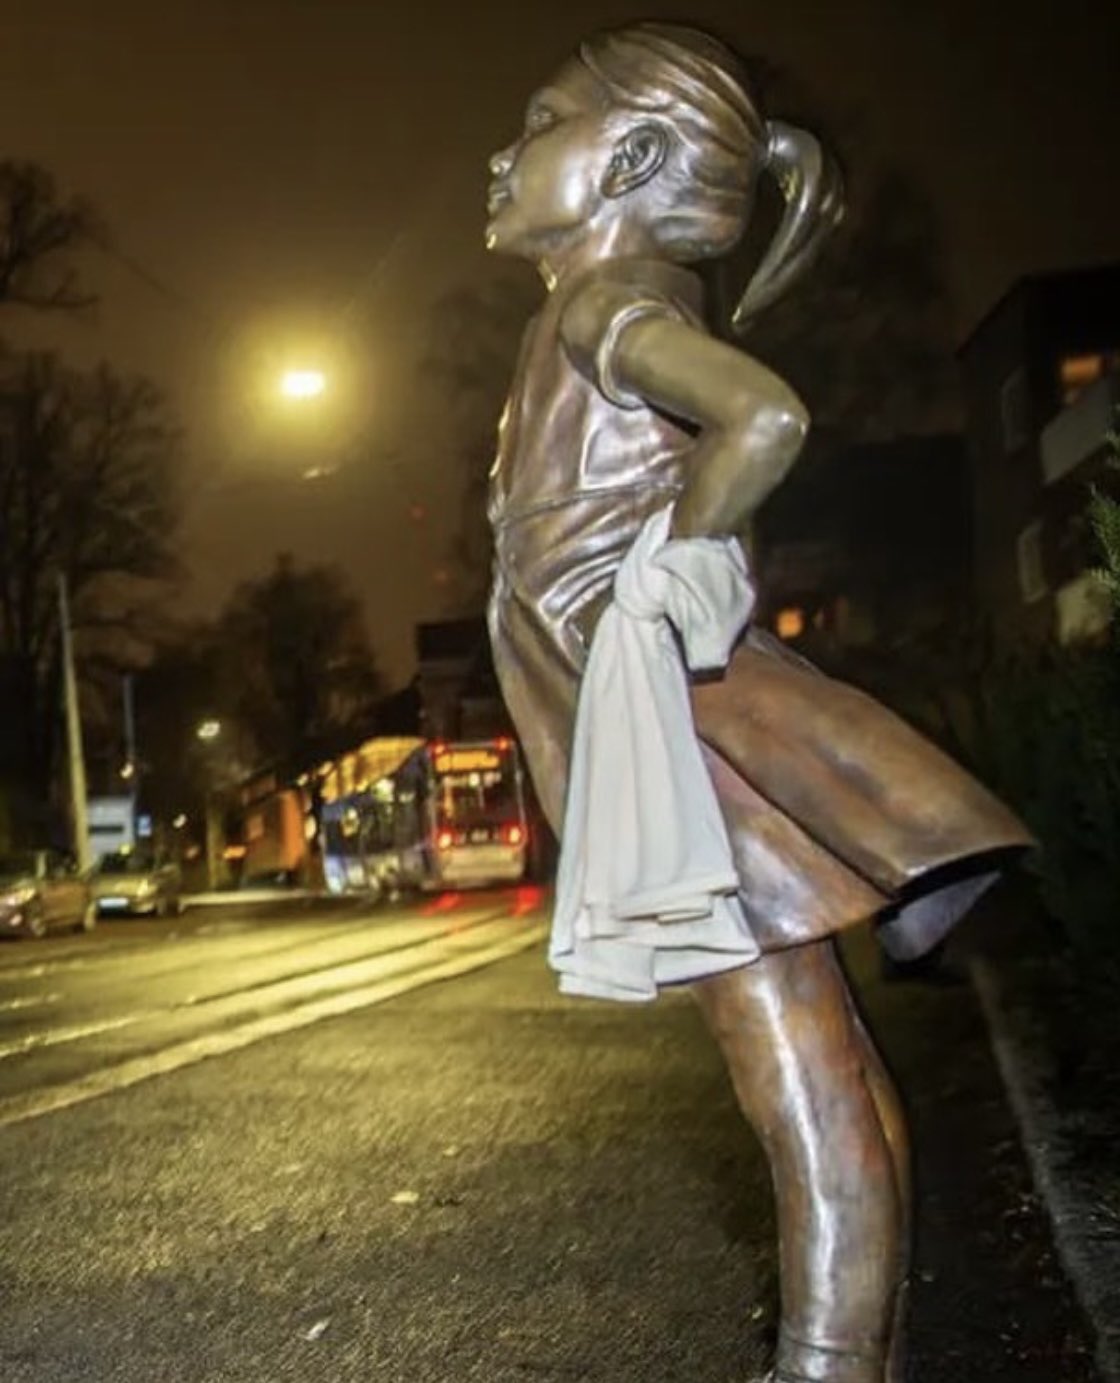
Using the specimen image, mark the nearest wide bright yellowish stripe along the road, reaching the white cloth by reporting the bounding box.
[0,922,548,1127]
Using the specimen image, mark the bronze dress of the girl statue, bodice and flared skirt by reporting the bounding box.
[489,260,1030,957]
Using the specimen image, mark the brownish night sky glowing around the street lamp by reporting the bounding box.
[0,0,1120,683]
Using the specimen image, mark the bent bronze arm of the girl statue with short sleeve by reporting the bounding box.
[560,282,809,538]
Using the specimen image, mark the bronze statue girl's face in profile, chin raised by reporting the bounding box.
[487,59,615,260]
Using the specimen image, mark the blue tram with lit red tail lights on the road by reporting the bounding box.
[321,737,530,896]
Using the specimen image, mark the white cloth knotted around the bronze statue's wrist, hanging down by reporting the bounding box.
[549,509,759,1000]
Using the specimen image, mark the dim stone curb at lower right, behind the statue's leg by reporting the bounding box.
[968,956,1120,1383]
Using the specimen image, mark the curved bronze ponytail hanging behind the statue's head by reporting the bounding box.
[731,120,843,333]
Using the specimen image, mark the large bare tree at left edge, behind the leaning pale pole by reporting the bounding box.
[0,355,177,818]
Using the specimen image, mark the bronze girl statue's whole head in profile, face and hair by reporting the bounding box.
[487,24,839,326]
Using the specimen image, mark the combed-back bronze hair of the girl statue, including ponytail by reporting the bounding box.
[579,24,843,326]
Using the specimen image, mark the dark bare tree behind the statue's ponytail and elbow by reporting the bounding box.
[713,58,961,442]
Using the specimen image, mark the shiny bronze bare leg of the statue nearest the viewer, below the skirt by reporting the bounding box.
[694,940,906,1383]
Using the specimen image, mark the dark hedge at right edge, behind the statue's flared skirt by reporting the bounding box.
[855,425,1120,985]
